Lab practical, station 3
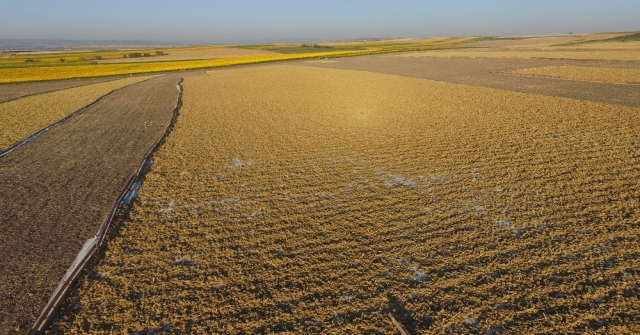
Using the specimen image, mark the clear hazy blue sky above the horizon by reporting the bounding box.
[0,0,640,44]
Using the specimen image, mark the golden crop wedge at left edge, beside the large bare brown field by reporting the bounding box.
[0,76,155,150]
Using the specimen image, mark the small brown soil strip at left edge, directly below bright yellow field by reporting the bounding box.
[0,77,118,103]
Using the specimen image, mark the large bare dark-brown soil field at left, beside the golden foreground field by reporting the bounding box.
[0,74,182,334]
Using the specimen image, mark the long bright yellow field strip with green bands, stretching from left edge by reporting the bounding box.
[0,38,474,84]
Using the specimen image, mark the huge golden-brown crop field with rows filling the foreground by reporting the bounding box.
[51,66,640,334]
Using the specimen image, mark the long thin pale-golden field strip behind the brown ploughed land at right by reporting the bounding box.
[393,50,640,61]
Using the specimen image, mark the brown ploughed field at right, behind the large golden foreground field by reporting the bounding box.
[296,54,640,107]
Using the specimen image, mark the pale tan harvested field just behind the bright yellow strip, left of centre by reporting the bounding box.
[97,47,277,63]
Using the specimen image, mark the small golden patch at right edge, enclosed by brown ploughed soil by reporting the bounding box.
[513,66,640,84]
